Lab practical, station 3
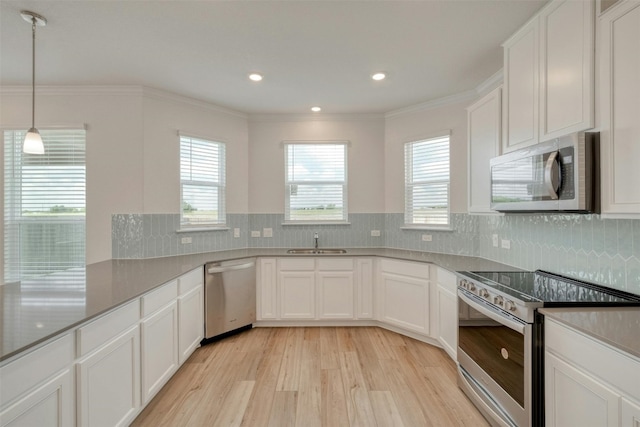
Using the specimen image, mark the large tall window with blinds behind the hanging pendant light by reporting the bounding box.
[4,130,86,282]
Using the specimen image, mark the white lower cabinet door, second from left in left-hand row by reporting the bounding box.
[76,325,140,427]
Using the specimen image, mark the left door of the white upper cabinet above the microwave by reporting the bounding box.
[502,18,539,153]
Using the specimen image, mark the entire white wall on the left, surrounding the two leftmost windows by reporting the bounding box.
[0,86,248,267]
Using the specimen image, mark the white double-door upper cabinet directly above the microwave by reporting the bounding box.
[503,0,595,152]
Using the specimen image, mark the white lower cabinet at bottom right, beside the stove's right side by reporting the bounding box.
[545,319,640,427]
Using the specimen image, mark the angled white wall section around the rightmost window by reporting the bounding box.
[384,99,473,213]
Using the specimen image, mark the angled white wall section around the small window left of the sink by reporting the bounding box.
[141,89,249,213]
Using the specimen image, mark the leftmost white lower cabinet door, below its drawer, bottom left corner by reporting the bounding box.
[0,369,75,427]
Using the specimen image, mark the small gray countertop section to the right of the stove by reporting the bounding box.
[539,307,640,358]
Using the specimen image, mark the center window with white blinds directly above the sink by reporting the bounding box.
[285,142,347,222]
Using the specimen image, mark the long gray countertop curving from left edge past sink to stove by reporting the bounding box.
[0,248,517,362]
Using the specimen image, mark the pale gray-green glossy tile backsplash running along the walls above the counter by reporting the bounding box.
[112,213,640,294]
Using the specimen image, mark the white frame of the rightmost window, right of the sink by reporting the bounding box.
[404,132,451,230]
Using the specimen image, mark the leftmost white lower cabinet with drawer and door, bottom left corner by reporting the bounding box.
[0,334,75,427]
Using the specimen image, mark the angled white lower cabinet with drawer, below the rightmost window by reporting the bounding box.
[377,258,431,336]
